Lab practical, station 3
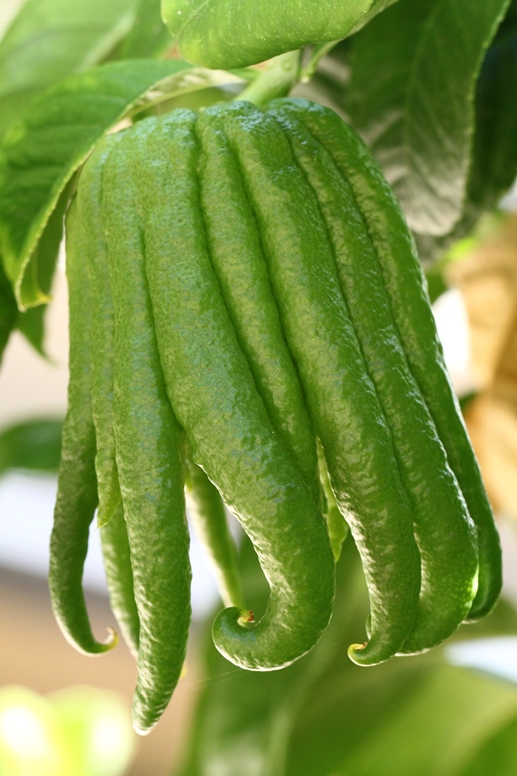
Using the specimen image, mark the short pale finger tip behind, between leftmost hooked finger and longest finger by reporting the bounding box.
[99,499,140,659]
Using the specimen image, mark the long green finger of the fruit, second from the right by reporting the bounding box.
[269,101,478,652]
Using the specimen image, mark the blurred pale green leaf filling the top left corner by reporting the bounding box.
[0,0,136,137]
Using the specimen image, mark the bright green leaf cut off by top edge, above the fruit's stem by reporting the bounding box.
[162,0,394,69]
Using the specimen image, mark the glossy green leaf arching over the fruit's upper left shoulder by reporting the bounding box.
[0,60,236,309]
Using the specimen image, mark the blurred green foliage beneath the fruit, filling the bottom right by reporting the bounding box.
[181,537,517,776]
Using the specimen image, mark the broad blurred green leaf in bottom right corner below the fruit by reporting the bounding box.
[285,658,517,776]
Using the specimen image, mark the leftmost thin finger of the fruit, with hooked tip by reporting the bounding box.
[49,192,116,655]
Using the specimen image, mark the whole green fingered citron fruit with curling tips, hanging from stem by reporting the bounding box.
[51,99,501,733]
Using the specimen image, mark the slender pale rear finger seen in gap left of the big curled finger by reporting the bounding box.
[185,457,244,609]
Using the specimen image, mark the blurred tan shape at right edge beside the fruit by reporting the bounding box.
[449,214,517,519]
